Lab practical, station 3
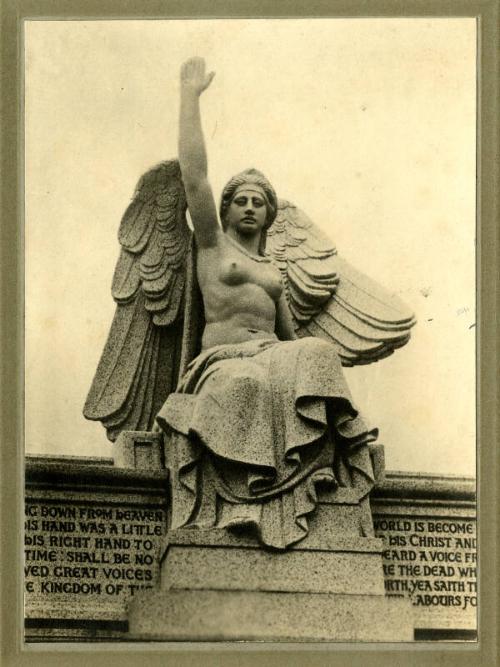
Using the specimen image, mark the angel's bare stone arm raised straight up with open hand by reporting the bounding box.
[179,58,221,248]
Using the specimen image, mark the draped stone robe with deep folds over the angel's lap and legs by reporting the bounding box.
[157,335,376,549]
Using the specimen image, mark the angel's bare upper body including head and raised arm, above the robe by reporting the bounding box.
[179,58,296,350]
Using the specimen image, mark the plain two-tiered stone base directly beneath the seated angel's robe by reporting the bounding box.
[128,529,413,642]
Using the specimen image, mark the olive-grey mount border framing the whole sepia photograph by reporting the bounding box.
[0,0,500,667]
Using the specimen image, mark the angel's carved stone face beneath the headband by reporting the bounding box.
[224,184,267,236]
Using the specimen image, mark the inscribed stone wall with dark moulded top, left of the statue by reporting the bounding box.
[24,458,167,625]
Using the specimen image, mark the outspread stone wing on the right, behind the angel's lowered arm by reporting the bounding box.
[266,200,415,366]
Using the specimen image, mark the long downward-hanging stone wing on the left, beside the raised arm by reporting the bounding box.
[83,160,193,440]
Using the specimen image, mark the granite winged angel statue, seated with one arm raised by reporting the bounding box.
[84,58,414,549]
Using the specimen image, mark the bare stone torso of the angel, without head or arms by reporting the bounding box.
[197,232,283,349]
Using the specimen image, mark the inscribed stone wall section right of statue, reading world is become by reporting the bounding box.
[372,473,478,638]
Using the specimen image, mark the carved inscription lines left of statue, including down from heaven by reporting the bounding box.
[24,502,166,603]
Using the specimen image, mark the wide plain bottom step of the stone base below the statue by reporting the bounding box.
[129,590,413,642]
